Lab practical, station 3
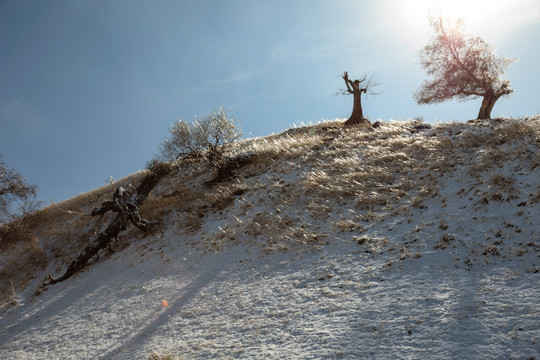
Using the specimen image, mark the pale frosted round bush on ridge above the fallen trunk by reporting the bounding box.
[160,106,242,169]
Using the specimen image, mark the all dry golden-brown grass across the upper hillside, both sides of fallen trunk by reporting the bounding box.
[0,117,540,296]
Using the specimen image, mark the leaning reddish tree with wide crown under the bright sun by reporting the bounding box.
[414,16,516,119]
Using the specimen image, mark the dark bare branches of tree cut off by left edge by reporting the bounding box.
[0,155,39,224]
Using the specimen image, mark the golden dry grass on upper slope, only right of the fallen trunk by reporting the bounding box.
[187,119,539,251]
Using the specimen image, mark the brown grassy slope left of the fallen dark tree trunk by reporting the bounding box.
[0,173,150,303]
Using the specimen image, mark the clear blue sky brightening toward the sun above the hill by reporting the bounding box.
[0,0,540,203]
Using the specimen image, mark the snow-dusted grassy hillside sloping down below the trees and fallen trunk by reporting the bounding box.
[0,117,540,359]
